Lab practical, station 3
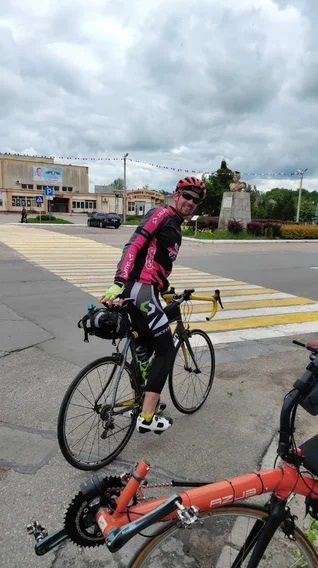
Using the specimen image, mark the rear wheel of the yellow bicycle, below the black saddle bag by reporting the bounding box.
[57,357,141,470]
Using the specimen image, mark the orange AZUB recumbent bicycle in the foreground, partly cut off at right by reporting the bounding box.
[28,342,318,568]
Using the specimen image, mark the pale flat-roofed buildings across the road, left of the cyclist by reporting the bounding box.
[0,154,166,217]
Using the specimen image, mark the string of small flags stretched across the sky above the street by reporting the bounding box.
[0,152,303,177]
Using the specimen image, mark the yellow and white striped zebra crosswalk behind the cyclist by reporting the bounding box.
[0,225,318,344]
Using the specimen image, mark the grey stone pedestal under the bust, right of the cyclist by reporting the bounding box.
[218,191,251,229]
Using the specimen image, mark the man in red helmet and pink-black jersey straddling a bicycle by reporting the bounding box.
[100,176,206,433]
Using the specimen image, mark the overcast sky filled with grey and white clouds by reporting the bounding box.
[0,0,318,190]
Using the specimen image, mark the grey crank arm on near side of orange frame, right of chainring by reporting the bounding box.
[105,493,181,552]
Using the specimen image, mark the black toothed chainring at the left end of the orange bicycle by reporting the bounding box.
[64,477,124,547]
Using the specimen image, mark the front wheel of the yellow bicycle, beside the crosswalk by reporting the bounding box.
[168,329,215,414]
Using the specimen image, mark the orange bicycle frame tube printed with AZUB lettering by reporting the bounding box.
[96,462,318,552]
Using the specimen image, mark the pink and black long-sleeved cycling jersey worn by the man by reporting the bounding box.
[115,206,183,292]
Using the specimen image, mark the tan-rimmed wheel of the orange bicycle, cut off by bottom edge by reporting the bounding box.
[129,504,318,568]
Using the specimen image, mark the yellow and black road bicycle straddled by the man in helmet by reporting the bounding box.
[58,289,223,470]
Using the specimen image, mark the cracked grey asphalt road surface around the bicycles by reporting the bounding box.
[0,216,318,568]
